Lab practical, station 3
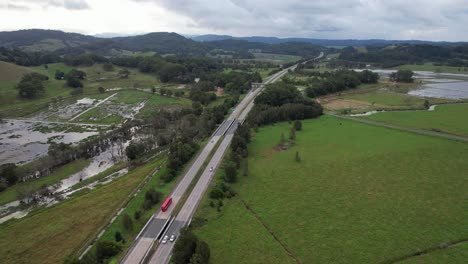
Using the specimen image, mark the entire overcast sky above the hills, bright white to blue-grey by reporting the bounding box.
[0,0,468,41]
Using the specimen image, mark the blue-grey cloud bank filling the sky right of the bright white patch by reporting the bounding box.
[133,0,468,39]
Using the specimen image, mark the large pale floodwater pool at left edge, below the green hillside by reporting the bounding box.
[0,120,98,165]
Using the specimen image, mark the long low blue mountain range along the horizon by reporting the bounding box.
[191,35,461,47]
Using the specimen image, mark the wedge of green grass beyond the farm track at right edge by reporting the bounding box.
[362,104,468,136]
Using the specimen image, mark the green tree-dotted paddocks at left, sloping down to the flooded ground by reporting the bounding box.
[0,62,189,118]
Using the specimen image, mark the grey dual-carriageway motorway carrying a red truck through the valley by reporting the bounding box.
[122,53,323,264]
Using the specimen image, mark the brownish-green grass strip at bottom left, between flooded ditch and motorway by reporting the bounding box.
[0,160,159,264]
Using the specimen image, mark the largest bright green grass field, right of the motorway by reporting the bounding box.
[196,116,468,263]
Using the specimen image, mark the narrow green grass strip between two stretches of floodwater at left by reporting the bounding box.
[0,160,90,205]
